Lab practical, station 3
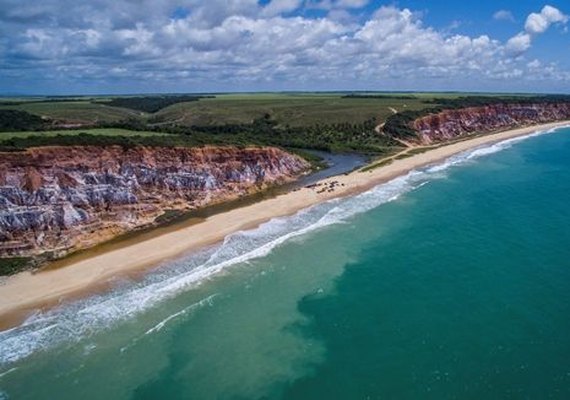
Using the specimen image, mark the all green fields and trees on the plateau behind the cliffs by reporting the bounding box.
[4,92,570,158]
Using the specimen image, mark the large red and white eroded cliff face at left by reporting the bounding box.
[0,146,309,257]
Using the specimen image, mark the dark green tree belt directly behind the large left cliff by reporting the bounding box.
[0,114,400,154]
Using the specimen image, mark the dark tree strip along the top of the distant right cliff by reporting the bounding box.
[383,95,570,139]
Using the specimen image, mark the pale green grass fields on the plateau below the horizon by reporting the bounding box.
[0,92,524,127]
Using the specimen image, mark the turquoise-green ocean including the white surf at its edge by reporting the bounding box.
[0,128,570,400]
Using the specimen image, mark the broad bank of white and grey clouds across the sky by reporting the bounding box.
[0,0,569,91]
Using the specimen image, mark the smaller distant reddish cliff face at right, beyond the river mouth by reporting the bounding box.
[412,103,570,144]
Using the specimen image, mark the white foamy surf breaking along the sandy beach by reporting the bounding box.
[0,125,564,368]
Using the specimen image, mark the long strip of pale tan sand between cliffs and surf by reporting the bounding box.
[0,121,570,330]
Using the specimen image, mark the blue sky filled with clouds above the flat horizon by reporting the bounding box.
[0,0,570,95]
